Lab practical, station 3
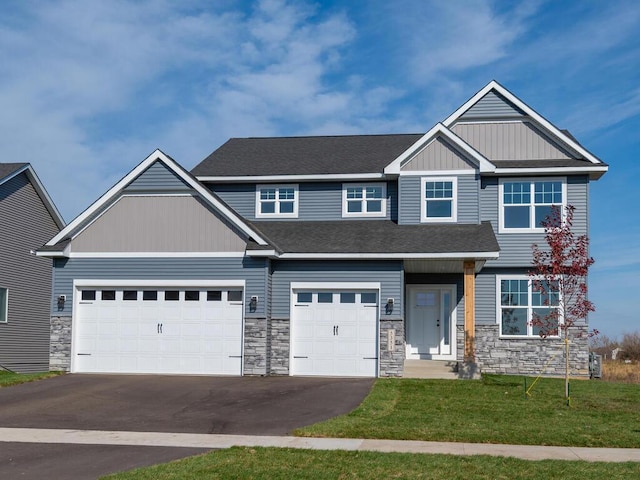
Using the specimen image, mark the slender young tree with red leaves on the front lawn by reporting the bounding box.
[529,205,597,400]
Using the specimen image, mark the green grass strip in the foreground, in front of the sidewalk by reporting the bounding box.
[103,447,640,480]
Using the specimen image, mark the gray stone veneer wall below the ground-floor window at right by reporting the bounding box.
[476,325,589,376]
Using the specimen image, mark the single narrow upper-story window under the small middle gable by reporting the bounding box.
[421,177,458,222]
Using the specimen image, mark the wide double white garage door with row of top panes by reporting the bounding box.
[73,287,243,375]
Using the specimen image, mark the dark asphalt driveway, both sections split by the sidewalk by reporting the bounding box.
[0,375,373,480]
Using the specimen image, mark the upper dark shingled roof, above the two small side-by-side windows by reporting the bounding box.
[191,134,422,177]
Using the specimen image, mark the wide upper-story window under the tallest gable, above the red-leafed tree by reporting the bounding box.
[499,178,567,232]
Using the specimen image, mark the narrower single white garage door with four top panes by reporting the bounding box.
[291,289,378,377]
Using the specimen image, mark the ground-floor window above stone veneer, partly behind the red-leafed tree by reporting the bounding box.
[497,276,560,337]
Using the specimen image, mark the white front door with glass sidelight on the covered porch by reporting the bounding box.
[406,285,456,360]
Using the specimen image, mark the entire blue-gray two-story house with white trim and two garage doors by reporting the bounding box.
[39,82,607,377]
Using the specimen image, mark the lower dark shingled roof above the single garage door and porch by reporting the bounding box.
[247,220,500,256]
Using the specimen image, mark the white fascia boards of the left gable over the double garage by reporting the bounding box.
[46,149,267,246]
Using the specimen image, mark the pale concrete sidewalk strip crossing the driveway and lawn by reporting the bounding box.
[0,428,640,462]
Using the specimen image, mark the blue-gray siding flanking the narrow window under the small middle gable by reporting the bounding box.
[398,173,480,225]
